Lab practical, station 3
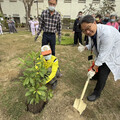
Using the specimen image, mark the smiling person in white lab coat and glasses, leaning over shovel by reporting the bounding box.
[78,15,120,101]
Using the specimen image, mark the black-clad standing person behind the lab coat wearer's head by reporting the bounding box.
[73,11,82,46]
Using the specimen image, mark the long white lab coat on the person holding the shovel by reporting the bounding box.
[86,24,120,81]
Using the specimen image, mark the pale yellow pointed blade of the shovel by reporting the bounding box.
[73,98,87,115]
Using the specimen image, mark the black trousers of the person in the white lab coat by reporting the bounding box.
[93,63,110,95]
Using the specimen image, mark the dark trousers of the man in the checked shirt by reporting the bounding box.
[42,32,56,56]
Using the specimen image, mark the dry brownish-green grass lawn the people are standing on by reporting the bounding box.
[0,30,120,120]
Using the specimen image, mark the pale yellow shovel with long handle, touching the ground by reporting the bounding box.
[73,77,90,115]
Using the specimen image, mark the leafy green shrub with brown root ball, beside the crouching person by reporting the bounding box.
[19,52,53,113]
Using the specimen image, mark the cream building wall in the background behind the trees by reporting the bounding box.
[1,0,120,23]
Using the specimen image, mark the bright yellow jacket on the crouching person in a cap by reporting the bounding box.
[40,55,59,83]
